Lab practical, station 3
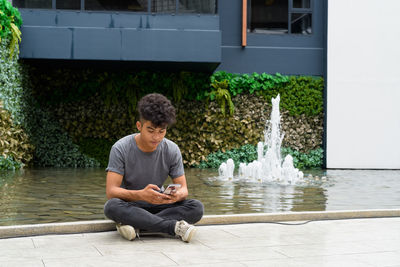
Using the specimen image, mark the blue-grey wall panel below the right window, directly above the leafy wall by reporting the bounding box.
[217,46,324,76]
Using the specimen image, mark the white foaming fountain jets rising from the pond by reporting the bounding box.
[219,95,304,184]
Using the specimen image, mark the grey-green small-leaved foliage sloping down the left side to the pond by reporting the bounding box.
[0,42,99,167]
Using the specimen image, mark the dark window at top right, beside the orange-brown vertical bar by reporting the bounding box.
[247,0,313,35]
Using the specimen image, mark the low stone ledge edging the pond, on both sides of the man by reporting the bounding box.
[0,209,400,238]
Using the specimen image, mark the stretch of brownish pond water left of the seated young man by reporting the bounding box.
[0,169,106,225]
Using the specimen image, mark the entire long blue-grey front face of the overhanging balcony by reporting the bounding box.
[21,26,221,62]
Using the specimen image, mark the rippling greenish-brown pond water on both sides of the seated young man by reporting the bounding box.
[0,168,400,225]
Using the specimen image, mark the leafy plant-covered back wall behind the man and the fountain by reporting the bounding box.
[29,69,323,170]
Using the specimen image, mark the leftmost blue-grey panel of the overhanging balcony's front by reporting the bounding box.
[20,26,72,59]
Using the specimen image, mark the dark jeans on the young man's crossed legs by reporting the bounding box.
[104,198,204,235]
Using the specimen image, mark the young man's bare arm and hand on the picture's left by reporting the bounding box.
[106,171,175,204]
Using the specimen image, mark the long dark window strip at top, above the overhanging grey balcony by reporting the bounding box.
[13,0,217,14]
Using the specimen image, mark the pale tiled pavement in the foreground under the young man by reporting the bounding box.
[0,217,400,267]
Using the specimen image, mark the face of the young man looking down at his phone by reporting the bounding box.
[136,120,167,151]
